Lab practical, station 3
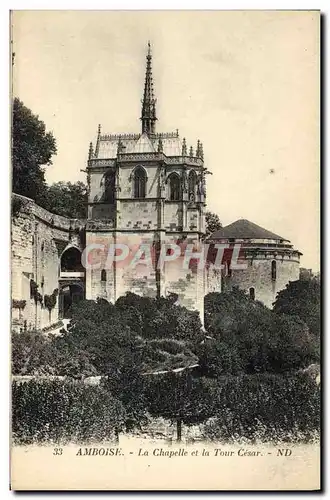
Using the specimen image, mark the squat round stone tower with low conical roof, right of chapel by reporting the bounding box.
[208,219,302,308]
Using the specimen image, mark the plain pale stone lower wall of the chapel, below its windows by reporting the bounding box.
[86,231,205,320]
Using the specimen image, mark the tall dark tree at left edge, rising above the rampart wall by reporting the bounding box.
[12,97,56,203]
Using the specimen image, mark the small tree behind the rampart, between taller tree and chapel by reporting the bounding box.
[44,181,88,219]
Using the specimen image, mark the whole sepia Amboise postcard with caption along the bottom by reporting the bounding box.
[10,10,321,491]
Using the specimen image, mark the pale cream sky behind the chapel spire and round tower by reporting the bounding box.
[13,11,319,270]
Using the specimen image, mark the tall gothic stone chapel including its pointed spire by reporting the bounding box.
[86,43,206,317]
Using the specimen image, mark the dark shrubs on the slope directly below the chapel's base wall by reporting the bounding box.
[64,294,201,374]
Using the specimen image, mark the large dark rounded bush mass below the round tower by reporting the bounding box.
[202,289,319,376]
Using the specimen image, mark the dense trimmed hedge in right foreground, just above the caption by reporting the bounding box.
[204,373,320,442]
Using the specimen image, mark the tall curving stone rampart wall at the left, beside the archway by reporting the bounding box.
[11,195,84,331]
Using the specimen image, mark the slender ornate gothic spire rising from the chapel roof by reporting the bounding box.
[141,42,157,135]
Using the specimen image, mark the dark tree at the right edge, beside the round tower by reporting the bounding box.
[273,277,321,338]
